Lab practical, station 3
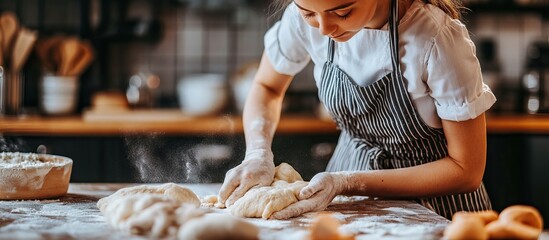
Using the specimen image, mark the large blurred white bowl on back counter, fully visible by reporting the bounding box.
[177,74,228,116]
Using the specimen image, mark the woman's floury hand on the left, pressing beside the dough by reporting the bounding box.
[219,149,275,207]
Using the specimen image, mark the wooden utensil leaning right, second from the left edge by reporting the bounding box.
[11,28,37,72]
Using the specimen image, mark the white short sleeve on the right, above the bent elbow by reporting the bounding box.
[425,20,496,121]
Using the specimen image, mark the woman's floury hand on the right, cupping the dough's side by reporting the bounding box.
[271,172,349,219]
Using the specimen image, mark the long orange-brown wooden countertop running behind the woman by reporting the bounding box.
[0,110,549,136]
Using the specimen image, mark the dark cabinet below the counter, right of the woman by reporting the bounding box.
[484,134,549,227]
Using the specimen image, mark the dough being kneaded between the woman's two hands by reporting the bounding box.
[229,163,308,219]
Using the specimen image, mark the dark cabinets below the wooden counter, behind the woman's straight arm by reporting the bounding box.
[17,134,337,183]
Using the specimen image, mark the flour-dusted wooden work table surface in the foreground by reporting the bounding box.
[0,183,449,239]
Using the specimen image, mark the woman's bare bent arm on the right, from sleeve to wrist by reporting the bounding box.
[340,114,486,197]
